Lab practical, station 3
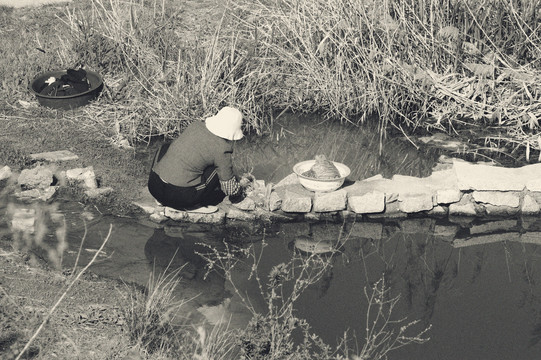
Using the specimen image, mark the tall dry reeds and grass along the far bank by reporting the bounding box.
[3,0,541,159]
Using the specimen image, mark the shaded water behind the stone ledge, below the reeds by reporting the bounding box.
[233,114,441,183]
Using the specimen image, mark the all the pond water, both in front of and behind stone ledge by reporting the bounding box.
[3,119,541,360]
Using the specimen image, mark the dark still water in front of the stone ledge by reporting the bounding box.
[19,208,541,360]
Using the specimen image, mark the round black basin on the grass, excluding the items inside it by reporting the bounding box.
[28,70,103,109]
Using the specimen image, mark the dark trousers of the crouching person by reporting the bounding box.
[148,144,225,210]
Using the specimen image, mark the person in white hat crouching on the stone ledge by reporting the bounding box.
[148,107,243,213]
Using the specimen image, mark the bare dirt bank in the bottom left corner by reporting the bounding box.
[0,243,144,360]
